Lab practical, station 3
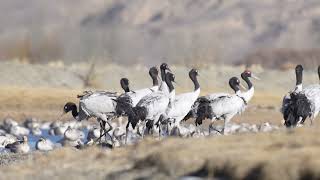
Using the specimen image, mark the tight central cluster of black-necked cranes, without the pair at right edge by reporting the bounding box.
[64,63,258,143]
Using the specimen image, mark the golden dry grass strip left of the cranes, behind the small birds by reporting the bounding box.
[0,87,82,120]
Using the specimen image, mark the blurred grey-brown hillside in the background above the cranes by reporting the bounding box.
[0,0,320,68]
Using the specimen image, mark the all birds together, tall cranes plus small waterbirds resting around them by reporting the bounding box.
[0,63,320,153]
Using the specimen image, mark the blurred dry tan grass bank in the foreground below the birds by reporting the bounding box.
[0,127,320,179]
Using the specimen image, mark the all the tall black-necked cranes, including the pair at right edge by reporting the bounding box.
[60,63,320,146]
